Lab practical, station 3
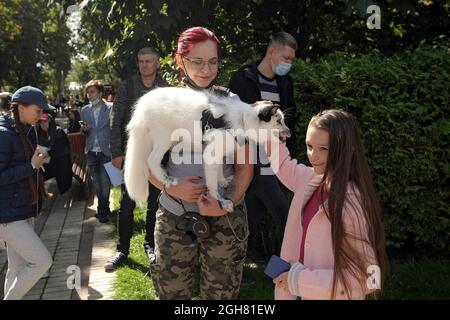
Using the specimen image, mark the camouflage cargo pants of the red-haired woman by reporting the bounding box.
[150,204,248,300]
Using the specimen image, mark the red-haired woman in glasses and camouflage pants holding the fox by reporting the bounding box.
[150,27,253,300]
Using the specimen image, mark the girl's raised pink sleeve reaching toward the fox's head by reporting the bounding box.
[269,143,315,191]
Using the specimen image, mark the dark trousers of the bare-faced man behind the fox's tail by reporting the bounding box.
[117,183,161,255]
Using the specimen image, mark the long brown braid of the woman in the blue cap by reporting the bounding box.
[12,104,46,204]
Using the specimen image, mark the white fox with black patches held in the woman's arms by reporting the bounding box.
[124,88,290,211]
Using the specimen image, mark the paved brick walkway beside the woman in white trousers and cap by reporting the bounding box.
[0,180,115,300]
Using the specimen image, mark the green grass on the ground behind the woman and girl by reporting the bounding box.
[111,189,450,300]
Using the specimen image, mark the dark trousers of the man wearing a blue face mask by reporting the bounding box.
[245,164,289,241]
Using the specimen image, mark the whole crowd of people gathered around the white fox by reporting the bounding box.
[0,27,386,299]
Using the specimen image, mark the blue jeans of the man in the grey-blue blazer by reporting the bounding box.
[87,151,111,216]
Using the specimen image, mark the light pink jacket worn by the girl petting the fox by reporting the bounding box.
[269,144,376,300]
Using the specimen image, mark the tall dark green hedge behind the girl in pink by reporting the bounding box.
[292,46,450,255]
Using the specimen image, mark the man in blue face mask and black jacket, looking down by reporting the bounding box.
[229,32,298,262]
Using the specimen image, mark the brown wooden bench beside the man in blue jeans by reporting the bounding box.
[67,132,91,195]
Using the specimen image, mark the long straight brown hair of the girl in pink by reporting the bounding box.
[309,109,387,298]
